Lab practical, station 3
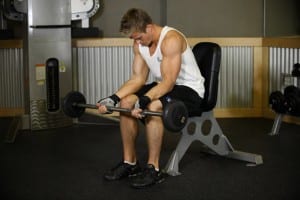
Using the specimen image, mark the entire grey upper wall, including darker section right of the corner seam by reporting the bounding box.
[4,0,300,37]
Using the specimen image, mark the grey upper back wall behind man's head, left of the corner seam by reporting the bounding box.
[92,0,263,37]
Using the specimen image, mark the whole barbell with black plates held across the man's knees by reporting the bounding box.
[62,91,188,132]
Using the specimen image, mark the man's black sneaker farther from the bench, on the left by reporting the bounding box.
[103,161,141,181]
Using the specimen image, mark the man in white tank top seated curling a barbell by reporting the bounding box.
[97,8,204,188]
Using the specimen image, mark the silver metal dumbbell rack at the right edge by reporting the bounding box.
[269,74,300,136]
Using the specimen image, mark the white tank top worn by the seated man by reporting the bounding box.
[139,26,204,98]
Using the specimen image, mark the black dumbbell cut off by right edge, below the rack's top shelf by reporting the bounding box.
[284,85,300,115]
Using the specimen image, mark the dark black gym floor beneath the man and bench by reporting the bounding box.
[0,114,300,200]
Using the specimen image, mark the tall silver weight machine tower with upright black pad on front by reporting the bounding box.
[22,0,73,130]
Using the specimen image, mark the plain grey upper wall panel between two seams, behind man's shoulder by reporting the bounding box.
[167,0,263,37]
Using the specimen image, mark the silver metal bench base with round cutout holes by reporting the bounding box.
[165,111,263,176]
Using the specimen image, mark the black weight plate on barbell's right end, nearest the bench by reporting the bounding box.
[162,100,188,132]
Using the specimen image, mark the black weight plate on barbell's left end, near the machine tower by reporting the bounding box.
[62,91,86,118]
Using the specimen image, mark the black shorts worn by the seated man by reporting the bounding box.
[135,82,203,116]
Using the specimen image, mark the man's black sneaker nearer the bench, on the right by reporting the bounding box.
[131,164,165,188]
